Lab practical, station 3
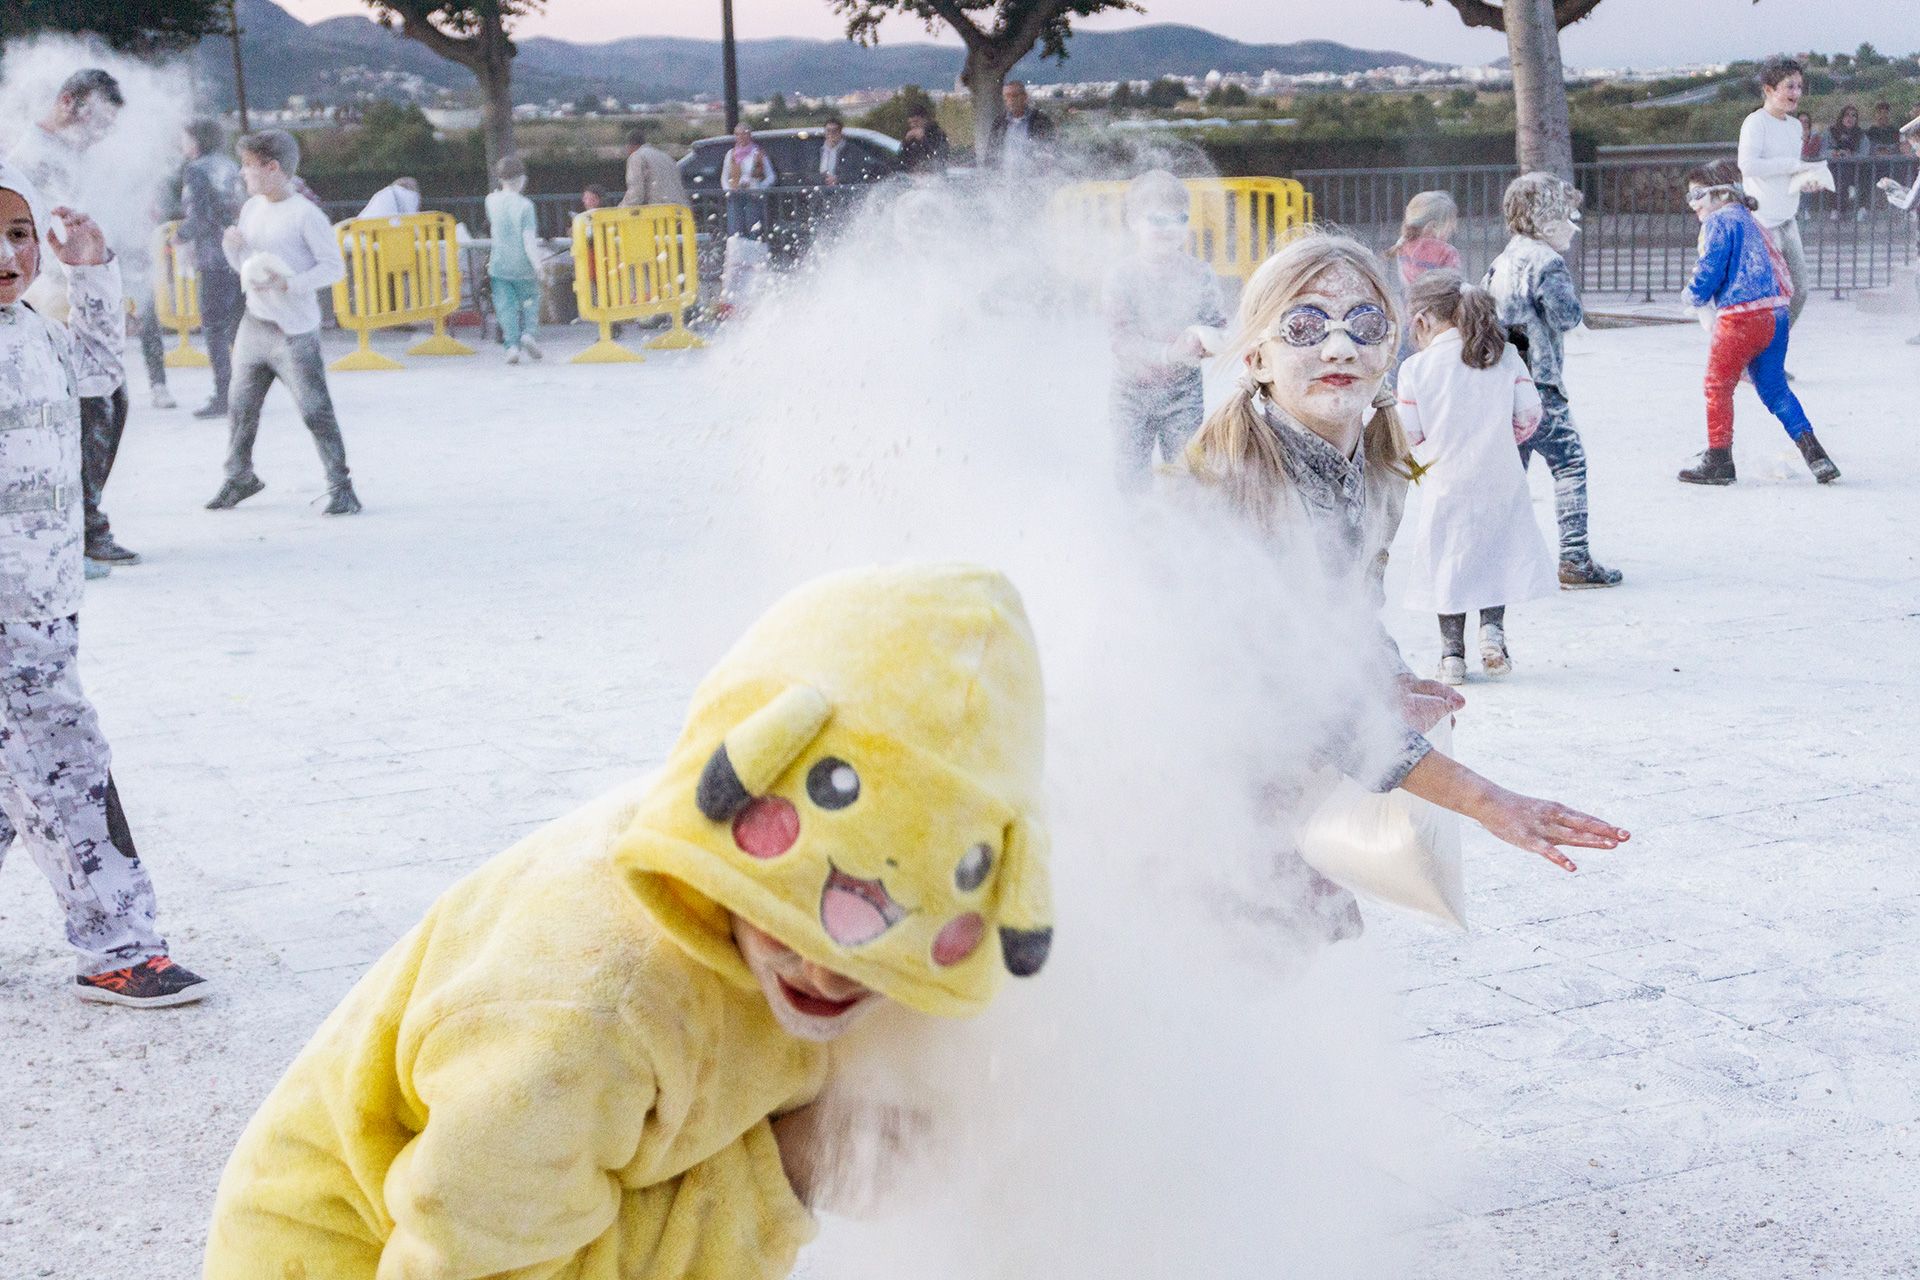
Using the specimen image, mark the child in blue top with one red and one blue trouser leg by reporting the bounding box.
[1680,161,1839,484]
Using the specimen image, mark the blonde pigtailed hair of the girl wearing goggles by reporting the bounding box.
[1187,232,1409,524]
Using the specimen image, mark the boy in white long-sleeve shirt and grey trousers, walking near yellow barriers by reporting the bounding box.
[207,129,361,516]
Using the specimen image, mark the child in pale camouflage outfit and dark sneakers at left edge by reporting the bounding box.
[0,161,205,1006]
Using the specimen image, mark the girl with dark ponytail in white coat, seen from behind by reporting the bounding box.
[1398,271,1555,685]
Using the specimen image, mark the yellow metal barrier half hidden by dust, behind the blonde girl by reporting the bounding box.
[1052,178,1313,284]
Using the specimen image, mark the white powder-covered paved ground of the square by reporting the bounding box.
[0,297,1920,1280]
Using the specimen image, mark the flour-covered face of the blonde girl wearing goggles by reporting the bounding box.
[1248,265,1396,449]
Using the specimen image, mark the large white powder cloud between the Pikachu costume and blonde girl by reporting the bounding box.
[676,169,1425,1280]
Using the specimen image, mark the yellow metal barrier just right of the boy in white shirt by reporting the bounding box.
[328,213,474,370]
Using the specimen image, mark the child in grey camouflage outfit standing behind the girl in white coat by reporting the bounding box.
[1486,173,1620,591]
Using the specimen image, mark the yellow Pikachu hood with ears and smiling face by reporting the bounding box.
[616,564,1052,1015]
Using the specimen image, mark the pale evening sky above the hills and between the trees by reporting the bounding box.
[278,0,1920,67]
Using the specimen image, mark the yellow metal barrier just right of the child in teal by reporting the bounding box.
[574,205,707,365]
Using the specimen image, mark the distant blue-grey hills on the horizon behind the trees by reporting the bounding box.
[196,0,1432,106]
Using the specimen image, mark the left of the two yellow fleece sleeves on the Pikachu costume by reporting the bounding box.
[376,1002,655,1280]
